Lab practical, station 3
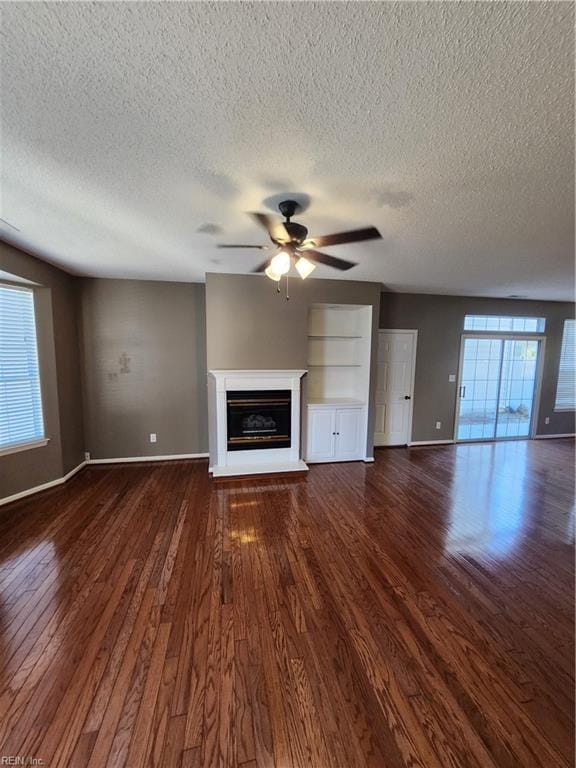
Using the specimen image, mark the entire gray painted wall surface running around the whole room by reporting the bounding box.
[0,242,575,498]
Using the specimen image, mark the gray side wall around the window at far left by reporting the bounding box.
[0,242,84,498]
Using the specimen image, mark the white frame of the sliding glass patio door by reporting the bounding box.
[452,331,546,444]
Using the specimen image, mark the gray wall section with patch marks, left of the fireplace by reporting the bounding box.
[82,278,208,459]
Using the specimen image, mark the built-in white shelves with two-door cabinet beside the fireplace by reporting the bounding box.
[305,304,372,461]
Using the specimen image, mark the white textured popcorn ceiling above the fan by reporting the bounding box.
[0,2,574,299]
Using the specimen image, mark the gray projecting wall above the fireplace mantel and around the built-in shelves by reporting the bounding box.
[206,274,381,456]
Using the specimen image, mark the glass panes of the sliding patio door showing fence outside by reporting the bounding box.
[456,337,540,440]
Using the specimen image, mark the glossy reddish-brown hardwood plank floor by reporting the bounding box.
[0,440,574,768]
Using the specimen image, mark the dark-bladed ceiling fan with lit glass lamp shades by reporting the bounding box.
[218,200,382,282]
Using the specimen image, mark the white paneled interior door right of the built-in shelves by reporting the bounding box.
[374,331,417,445]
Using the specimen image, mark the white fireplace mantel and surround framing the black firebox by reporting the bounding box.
[209,369,308,477]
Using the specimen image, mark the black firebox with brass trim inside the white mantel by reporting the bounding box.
[226,389,292,451]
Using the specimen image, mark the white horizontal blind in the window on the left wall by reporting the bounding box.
[0,285,44,450]
